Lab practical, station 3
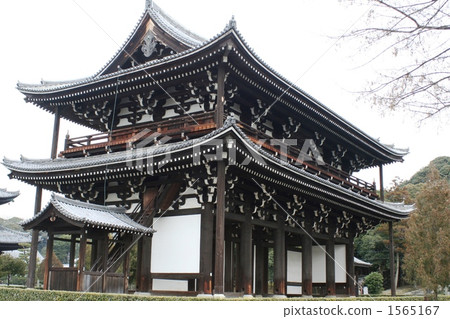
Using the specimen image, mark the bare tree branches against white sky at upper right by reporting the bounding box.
[347,0,450,120]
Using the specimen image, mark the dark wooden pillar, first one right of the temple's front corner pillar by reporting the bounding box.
[240,211,253,295]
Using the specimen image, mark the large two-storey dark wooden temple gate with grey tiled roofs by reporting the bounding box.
[3,1,412,296]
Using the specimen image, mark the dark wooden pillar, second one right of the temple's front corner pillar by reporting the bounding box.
[273,216,286,295]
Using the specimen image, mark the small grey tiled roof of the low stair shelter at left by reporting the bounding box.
[21,194,154,235]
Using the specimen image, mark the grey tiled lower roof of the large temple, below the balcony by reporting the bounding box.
[3,116,414,219]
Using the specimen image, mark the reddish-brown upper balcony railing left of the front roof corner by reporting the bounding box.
[59,112,216,157]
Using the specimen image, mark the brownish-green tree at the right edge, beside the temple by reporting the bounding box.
[404,168,450,299]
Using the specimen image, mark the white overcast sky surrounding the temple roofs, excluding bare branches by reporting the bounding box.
[0,0,450,218]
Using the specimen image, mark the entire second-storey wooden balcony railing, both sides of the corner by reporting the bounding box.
[59,112,378,199]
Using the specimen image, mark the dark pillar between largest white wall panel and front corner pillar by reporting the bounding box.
[198,203,214,295]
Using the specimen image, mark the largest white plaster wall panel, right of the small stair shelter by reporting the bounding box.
[151,215,201,273]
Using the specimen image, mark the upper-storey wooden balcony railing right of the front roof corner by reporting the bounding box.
[238,122,378,198]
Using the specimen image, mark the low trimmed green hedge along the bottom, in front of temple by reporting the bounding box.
[0,287,450,301]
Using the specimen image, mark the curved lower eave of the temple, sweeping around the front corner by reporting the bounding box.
[4,118,413,220]
